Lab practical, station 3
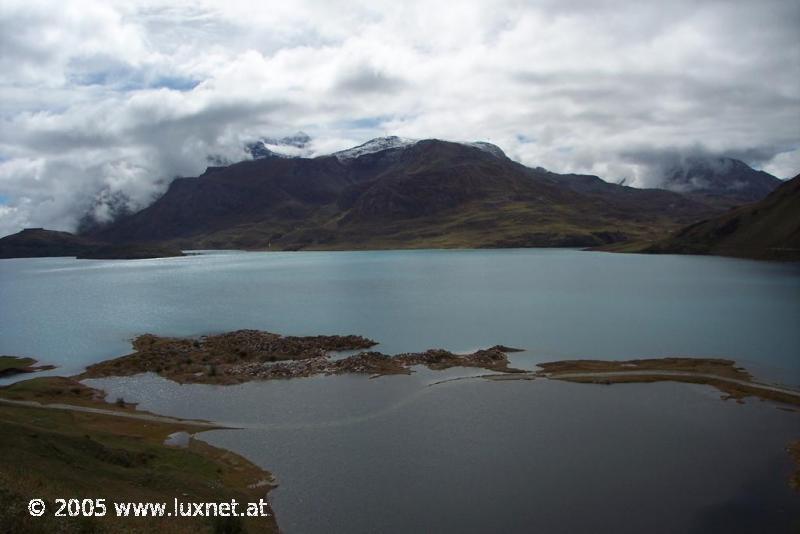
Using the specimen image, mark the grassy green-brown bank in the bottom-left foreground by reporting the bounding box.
[0,400,278,533]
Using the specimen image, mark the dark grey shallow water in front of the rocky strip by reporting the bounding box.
[87,369,800,533]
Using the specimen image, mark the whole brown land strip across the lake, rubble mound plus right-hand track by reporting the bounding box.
[75,330,800,405]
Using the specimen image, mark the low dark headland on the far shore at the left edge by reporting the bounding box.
[0,228,183,259]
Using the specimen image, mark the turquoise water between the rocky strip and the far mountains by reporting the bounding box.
[0,249,800,385]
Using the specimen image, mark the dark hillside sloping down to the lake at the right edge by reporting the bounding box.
[609,175,800,261]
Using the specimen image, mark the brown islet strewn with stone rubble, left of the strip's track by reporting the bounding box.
[78,330,518,384]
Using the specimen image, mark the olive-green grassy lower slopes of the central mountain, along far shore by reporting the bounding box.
[175,200,680,250]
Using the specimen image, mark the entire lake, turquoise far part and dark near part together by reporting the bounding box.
[0,249,800,532]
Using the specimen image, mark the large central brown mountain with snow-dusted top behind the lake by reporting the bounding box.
[86,137,714,249]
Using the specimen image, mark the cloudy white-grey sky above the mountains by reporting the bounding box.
[0,0,800,235]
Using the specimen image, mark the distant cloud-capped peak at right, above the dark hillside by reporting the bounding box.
[663,156,782,207]
